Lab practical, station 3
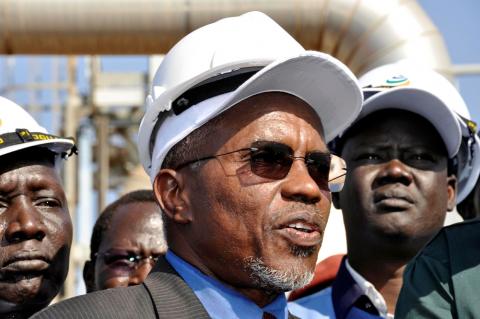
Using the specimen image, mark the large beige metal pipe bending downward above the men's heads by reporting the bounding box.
[0,0,450,74]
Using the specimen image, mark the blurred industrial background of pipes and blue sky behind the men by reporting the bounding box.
[0,0,480,297]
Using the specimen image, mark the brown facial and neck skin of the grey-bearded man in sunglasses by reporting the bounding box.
[154,93,331,307]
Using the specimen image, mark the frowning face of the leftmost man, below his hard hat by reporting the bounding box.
[0,150,72,318]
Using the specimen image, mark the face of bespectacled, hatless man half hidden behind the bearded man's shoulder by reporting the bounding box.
[83,202,166,292]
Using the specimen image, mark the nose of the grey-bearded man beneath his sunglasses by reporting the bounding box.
[282,160,322,204]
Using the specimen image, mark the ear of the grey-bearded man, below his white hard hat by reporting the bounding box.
[153,169,193,224]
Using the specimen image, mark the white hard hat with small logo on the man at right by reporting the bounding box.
[356,60,480,203]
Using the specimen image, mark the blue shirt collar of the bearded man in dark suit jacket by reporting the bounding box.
[165,250,288,319]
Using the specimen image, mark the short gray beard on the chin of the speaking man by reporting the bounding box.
[244,257,313,293]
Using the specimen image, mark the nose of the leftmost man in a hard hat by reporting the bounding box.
[5,200,46,243]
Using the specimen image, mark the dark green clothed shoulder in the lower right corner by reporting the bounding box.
[395,220,480,319]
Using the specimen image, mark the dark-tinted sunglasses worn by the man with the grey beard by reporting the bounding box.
[175,141,347,192]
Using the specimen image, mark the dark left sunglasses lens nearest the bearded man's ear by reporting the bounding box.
[250,143,292,180]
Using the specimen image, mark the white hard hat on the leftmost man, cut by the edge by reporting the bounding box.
[0,96,75,157]
